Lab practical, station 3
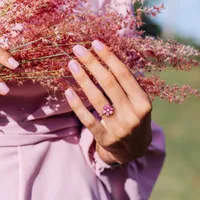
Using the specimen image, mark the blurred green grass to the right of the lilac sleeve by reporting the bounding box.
[150,69,200,200]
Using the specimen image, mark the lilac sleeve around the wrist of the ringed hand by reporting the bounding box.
[80,111,165,200]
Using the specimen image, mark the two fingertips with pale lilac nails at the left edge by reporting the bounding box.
[0,47,19,95]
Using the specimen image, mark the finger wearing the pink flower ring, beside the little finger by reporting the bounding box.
[68,60,109,119]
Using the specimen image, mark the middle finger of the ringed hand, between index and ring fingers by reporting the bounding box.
[73,45,128,107]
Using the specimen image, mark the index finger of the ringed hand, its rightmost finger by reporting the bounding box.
[92,40,147,104]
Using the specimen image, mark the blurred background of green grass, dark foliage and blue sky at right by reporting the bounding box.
[135,0,200,200]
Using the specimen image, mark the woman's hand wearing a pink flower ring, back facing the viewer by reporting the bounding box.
[65,40,152,164]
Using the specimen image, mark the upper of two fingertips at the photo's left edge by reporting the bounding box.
[0,47,19,69]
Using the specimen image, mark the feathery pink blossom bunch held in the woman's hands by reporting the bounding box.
[0,0,200,103]
